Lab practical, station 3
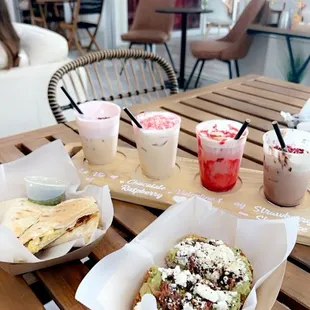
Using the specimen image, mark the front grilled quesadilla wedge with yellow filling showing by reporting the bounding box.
[19,197,99,254]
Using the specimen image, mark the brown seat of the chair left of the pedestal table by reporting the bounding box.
[121,30,170,44]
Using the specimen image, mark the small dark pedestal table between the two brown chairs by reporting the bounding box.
[156,8,213,89]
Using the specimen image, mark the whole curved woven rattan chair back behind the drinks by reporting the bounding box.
[48,50,179,123]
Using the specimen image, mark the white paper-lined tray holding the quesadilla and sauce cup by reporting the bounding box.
[0,141,113,275]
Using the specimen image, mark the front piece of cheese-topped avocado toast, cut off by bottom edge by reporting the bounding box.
[133,266,241,310]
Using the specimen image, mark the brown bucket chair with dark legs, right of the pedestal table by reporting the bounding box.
[185,0,266,90]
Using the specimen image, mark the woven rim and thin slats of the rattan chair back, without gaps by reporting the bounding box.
[48,50,179,123]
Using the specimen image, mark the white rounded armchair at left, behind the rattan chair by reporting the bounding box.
[0,24,70,138]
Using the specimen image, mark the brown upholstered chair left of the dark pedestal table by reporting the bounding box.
[121,0,176,72]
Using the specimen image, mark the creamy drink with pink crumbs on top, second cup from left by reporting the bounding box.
[133,111,181,179]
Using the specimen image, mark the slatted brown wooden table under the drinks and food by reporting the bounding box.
[0,76,310,310]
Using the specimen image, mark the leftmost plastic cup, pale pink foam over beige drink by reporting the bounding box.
[75,101,121,165]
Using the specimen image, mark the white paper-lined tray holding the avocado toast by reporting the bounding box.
[76,197,298,310]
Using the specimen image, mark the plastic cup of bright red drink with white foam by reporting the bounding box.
[196,120,248,192]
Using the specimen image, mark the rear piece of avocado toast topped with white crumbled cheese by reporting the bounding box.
[166,235,253,301]
